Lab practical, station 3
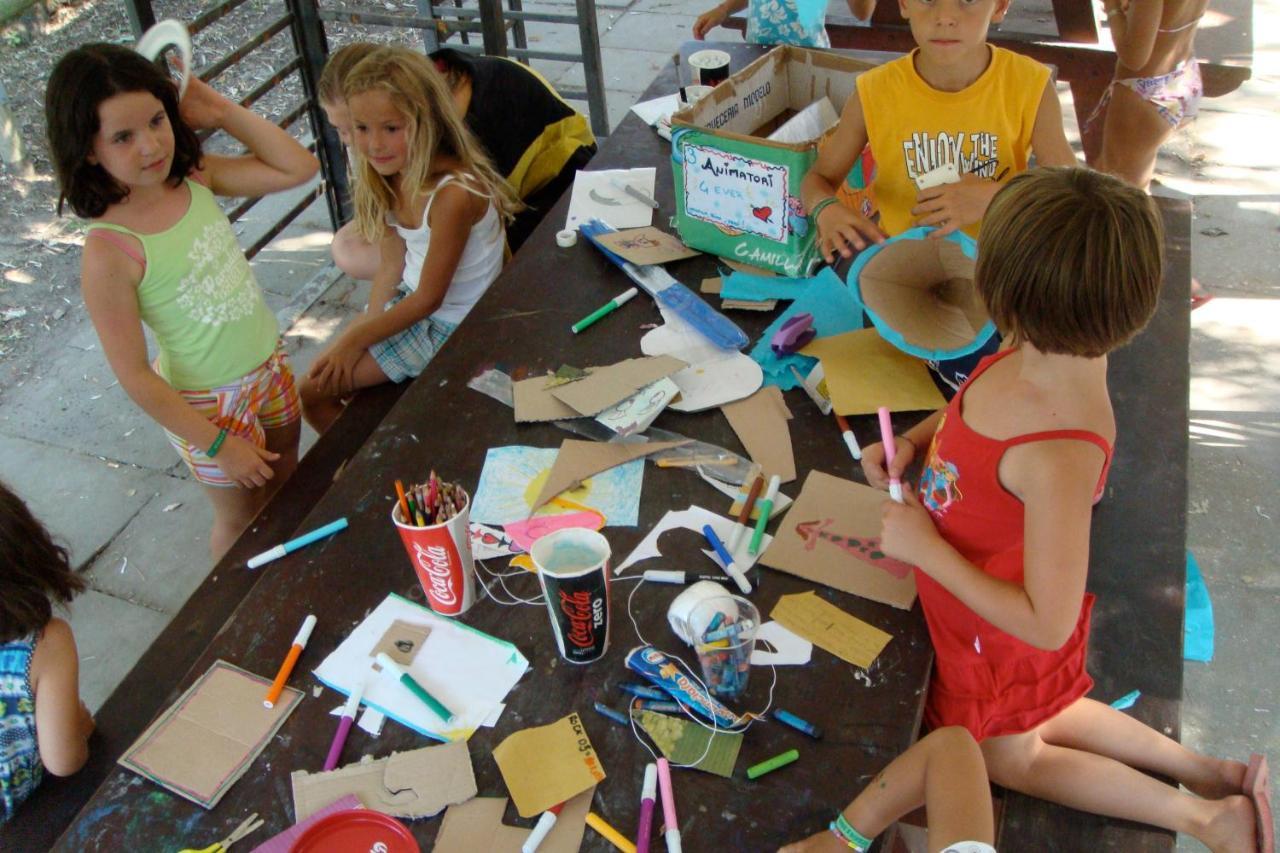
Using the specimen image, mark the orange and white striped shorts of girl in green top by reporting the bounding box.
[165,345,302,487]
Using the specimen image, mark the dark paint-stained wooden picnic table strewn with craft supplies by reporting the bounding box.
[12,46,1189,850]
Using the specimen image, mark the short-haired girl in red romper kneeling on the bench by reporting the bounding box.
[863,168,1274,853]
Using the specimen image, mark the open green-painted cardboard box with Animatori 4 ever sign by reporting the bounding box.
[671,46,872,275]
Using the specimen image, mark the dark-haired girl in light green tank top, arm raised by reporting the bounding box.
[45,44,319,560]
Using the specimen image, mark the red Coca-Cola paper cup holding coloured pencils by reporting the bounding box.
[392,489,476,616]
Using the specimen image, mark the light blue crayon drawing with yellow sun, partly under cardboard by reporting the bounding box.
[471,446,644,526]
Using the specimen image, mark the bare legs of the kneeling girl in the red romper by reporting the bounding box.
[982,699,1257,853]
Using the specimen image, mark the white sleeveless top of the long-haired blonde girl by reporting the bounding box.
[390,174,503,325]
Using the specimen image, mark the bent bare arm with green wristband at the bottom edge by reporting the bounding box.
[780,726,995,853]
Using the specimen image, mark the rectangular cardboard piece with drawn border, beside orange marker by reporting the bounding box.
[118,661,302,808]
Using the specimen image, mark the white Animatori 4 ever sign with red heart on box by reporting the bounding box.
[684,145,788,242]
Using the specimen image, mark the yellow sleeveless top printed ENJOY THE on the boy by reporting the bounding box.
[858,46,1050,237]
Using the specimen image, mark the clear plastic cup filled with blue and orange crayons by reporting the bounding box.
[689,594,760,699]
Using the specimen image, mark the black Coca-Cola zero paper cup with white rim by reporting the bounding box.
[529,528,611,663]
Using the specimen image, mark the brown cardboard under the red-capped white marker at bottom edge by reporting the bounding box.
[435,785,595,853]
